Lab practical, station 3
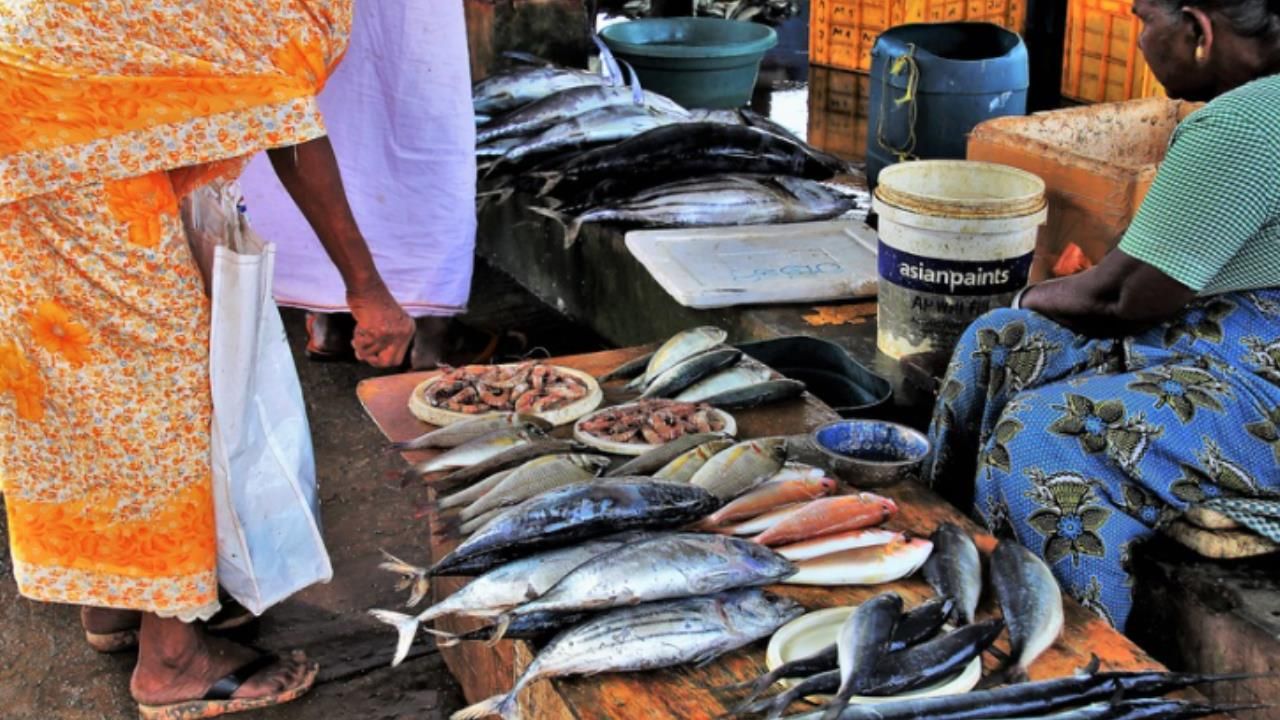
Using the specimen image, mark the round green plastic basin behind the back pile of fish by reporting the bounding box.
[600,18,778,108]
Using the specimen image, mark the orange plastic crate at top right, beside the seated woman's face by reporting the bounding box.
[1062,0,1164,102]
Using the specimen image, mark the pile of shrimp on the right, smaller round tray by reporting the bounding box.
[579,400,724,445]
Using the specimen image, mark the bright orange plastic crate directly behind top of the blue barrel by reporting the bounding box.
[809,0,1027,72]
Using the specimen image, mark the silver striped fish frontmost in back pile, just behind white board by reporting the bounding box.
[539,176,854,246]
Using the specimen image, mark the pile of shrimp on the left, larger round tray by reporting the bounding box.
[426,361,589,415]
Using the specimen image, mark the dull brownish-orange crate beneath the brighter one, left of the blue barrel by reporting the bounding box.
[808,67,872,161]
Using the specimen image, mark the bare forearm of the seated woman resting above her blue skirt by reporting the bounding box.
[1021,250,1196,337]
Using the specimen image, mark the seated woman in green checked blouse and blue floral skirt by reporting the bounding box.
[927,0,1280,629]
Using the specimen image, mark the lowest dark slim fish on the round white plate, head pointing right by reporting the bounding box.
[865,620,1005,696]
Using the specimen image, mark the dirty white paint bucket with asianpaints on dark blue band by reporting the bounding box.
[873,160,1048,359]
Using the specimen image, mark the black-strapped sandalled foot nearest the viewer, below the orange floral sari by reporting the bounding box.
[129,614,316,717]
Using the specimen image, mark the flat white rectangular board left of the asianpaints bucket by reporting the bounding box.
[626,220,878,309]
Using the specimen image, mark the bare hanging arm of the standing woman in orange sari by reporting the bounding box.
[268,137,413,368]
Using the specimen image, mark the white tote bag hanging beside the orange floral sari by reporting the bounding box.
[184,183,333,615]
